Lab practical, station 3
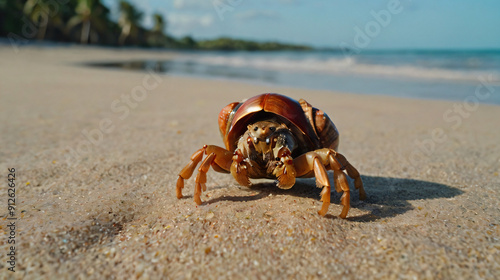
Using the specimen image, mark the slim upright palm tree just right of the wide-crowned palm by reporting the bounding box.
[118,0,143,45]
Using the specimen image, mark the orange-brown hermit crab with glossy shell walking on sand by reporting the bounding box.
[176,93,366,218]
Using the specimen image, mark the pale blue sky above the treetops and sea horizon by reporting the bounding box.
[103,0,500,49]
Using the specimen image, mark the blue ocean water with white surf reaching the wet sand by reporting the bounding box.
[92,50,500,105]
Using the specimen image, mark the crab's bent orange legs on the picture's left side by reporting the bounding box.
[176,145,232,202]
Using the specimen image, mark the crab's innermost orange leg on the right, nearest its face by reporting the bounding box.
[293,152,334,218]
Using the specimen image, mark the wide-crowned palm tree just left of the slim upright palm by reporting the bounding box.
[67,0,107,44]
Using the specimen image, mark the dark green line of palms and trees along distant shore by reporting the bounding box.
[0,0,311,51]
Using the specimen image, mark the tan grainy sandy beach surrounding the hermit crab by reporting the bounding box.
[0,45,500,279]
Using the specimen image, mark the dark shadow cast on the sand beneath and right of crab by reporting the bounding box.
[207,176,463,222]
